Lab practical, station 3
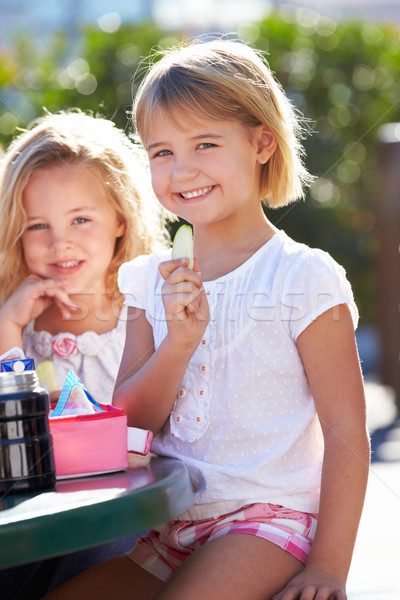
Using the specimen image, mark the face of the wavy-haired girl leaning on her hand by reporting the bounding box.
[21,163,125,294]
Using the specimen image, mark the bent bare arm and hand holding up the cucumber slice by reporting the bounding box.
[113,259,208,433]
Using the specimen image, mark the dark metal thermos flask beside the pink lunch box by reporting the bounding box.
[0,371,55,497]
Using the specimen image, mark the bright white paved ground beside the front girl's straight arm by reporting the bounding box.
[348,381,400,600]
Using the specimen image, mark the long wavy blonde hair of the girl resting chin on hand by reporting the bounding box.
[0,110,163,306]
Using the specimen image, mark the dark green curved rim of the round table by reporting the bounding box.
[0,458,193,569]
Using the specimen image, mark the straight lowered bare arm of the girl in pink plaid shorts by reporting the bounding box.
[274,304,370,600]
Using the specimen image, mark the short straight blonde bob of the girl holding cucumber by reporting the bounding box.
[133,40,313,208]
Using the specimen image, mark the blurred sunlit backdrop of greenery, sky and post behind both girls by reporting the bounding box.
[0,0,400,406]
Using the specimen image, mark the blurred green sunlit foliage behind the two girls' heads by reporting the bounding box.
[0,11,400,323]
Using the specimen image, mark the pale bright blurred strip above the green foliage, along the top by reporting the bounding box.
[0,0,400,35]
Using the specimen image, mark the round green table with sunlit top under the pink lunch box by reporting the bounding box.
[0,457,193,568]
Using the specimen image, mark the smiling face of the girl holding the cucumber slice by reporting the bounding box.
[146,109,275,231]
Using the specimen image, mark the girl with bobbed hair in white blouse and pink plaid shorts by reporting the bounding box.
[46,40,369,600]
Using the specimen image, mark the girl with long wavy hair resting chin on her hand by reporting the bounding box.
[0,110,161,403]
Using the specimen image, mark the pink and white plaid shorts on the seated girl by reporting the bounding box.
[126,503,317,581]
